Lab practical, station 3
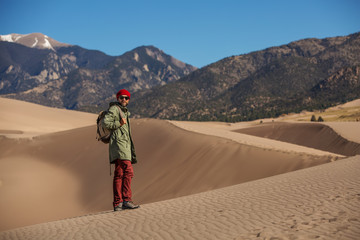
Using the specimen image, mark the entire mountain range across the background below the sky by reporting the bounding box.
[0,33,360,121]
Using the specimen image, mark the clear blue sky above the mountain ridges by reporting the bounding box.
[0,0,360,67]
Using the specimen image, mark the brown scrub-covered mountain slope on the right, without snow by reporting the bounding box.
[134,33,360,122]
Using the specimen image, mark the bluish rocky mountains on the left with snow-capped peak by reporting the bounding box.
[0,33,196,110]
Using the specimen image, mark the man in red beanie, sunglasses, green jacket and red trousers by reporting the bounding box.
[103,89,139,211]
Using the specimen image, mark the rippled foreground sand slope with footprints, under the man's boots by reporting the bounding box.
[0,156,360,240]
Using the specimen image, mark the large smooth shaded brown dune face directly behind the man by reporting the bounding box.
[0,120,333,230]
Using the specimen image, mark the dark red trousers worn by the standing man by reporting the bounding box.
[113,159,134,207]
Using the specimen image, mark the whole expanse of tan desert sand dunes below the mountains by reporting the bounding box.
[0,98,360,239]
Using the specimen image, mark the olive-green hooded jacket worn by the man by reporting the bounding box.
[102,102,137,164]
